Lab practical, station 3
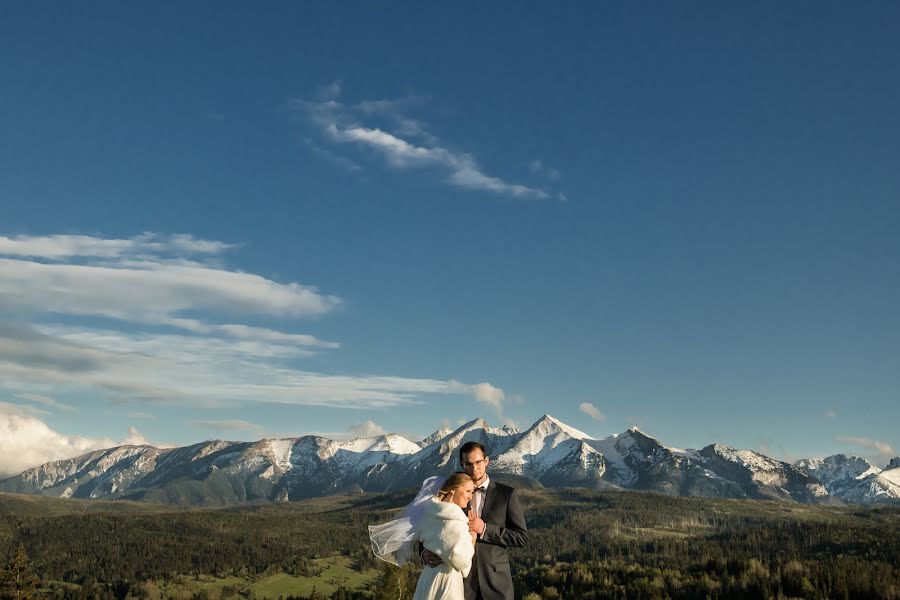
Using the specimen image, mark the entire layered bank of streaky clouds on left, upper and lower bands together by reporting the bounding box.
[0,233,505,440]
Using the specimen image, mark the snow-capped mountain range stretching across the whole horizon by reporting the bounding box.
[0,415,900,505]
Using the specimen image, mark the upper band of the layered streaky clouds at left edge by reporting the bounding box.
[0,233,341,348]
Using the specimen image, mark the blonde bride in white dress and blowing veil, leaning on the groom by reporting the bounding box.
[369,473,475,600]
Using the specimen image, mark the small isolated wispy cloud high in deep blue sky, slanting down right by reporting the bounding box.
[289,83,558,198]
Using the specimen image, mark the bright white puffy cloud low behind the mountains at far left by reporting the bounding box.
[0,404,146,478]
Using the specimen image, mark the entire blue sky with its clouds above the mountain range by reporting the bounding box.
[0,2,900,471]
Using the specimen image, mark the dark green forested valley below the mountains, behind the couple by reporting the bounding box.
[0,490,900,600]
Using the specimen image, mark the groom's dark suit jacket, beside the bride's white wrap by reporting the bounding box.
[465,480,528,600]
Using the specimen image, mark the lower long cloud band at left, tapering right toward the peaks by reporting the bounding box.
[0,325,503,408]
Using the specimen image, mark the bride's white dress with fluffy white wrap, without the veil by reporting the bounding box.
[413,498,475,600]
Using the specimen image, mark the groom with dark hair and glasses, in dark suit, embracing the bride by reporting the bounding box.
[422,442,528,600]
